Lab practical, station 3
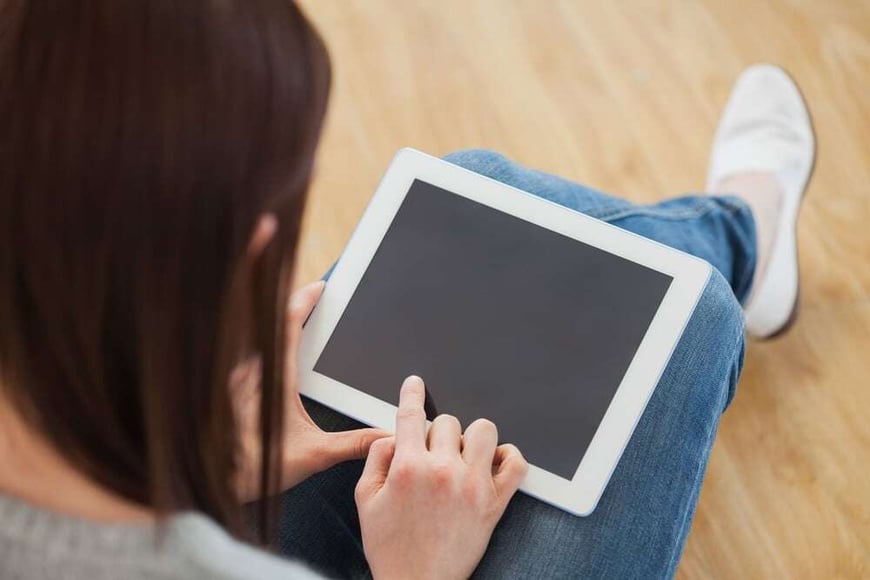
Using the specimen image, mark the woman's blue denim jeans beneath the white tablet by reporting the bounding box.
[280,151,755,578]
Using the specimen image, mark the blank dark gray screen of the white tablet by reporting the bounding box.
[314,180,672,479]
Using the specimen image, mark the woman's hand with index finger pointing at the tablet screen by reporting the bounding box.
[356,377,528,580]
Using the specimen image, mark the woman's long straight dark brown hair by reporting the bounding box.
[0,0,329,544]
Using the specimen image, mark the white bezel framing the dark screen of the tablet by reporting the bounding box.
[298,149,711,515]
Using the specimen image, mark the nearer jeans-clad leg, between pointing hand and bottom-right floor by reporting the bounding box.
[476,273,743,578]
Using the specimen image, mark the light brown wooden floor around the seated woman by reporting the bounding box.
[301,0,870,578]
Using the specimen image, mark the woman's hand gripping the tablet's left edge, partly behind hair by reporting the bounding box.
[237,281,389,501]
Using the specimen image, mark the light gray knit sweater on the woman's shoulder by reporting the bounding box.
[0,494,321,580]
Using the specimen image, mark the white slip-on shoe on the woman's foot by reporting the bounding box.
[707,64,815,339]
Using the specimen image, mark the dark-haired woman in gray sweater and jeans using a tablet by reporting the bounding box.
[0,0,813,578]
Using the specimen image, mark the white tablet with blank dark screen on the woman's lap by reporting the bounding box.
[299,149,710,515]
